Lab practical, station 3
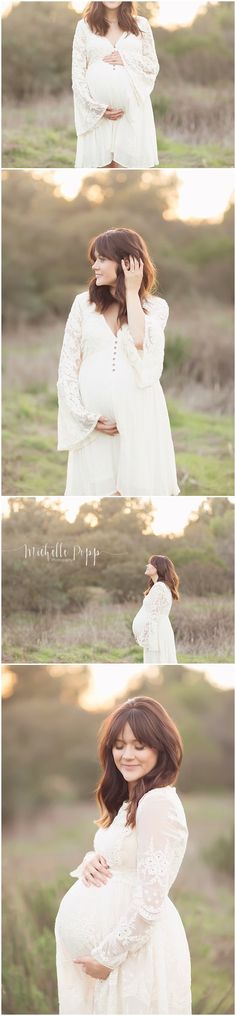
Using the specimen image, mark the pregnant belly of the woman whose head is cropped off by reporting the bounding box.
[86,60,129,113]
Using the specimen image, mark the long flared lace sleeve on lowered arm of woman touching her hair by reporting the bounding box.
[57,297,99,451]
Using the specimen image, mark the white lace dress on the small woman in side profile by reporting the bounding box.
[132,582,178,663]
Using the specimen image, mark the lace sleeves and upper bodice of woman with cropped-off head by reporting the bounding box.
[72,17,159,135]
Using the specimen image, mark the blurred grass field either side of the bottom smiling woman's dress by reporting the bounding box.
[3,793,234,1014]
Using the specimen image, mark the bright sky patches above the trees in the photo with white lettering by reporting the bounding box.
[2,496,221,535]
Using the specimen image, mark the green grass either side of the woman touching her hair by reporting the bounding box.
[3,386,234,495]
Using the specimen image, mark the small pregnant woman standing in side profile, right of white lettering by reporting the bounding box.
[132,554,179,663]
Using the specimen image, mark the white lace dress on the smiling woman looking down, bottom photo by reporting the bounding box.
[56,786,191,1016]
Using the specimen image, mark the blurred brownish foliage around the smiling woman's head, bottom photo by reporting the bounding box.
[3,664,234,823]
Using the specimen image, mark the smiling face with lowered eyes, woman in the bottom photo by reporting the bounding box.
[112,723,158,783]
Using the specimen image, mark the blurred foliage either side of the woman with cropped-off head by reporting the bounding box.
[3,0,234,101]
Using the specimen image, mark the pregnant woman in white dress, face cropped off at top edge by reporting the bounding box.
[72,0,159,169]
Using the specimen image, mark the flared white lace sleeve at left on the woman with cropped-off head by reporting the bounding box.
[72,19,107,135]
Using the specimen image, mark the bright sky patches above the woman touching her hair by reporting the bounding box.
[30,168,235,223]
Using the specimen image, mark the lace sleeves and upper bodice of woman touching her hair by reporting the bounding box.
[57,293,169,450]
